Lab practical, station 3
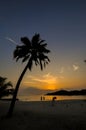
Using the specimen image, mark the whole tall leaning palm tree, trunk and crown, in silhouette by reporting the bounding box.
[8,34,50,117]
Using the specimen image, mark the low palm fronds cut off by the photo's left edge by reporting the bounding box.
[0,76,14,98]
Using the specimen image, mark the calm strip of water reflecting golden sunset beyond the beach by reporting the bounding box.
[18,95,86,101]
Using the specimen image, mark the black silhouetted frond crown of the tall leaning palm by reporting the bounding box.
[14,34,50,70]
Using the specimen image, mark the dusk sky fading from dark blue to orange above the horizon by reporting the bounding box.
[0,0,86,93]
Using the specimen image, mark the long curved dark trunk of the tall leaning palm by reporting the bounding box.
[7,64,28,117]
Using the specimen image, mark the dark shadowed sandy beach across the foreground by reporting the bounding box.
[0,100,86,130]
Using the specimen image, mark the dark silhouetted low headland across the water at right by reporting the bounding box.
[46,89,86,96]
